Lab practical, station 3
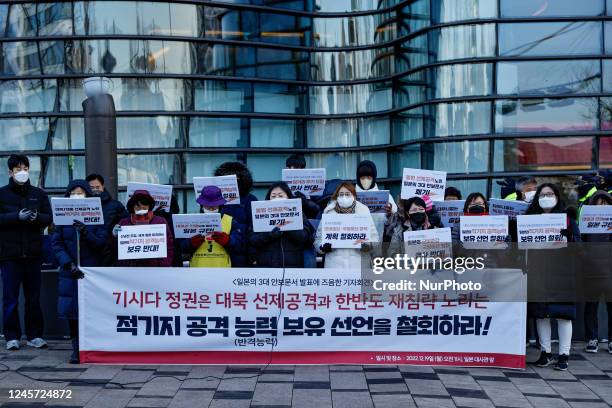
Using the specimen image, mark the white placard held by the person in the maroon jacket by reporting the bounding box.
[117,224,168,260]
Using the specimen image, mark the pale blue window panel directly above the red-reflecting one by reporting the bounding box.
[495,98,598,133]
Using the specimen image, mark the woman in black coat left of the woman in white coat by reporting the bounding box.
[248,182,314,268]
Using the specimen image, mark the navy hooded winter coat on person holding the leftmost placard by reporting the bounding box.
[51,180,108,319]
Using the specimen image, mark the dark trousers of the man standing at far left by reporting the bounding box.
[0,259,44,341]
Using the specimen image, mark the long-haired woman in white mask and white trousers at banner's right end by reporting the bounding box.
[527,183,580,371]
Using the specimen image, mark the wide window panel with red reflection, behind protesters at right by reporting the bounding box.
[493,137,593,171]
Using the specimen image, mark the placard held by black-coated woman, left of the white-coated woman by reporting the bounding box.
[251,198,304,232]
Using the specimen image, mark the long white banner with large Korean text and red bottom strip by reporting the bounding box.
[78,268,526,369]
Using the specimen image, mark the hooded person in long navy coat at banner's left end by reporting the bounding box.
[51,180,109,364]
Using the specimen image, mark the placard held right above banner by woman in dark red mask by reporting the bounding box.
[459,215,508,249]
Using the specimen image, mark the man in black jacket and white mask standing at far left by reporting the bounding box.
[0,155,52,350]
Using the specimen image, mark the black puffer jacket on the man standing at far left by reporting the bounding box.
[0,178,52,260]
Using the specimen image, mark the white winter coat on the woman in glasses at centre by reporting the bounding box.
[315,200,379,269]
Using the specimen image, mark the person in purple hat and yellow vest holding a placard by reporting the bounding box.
[180,186,245,268]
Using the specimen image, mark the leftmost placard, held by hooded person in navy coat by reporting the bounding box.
[51,197,104,225]
